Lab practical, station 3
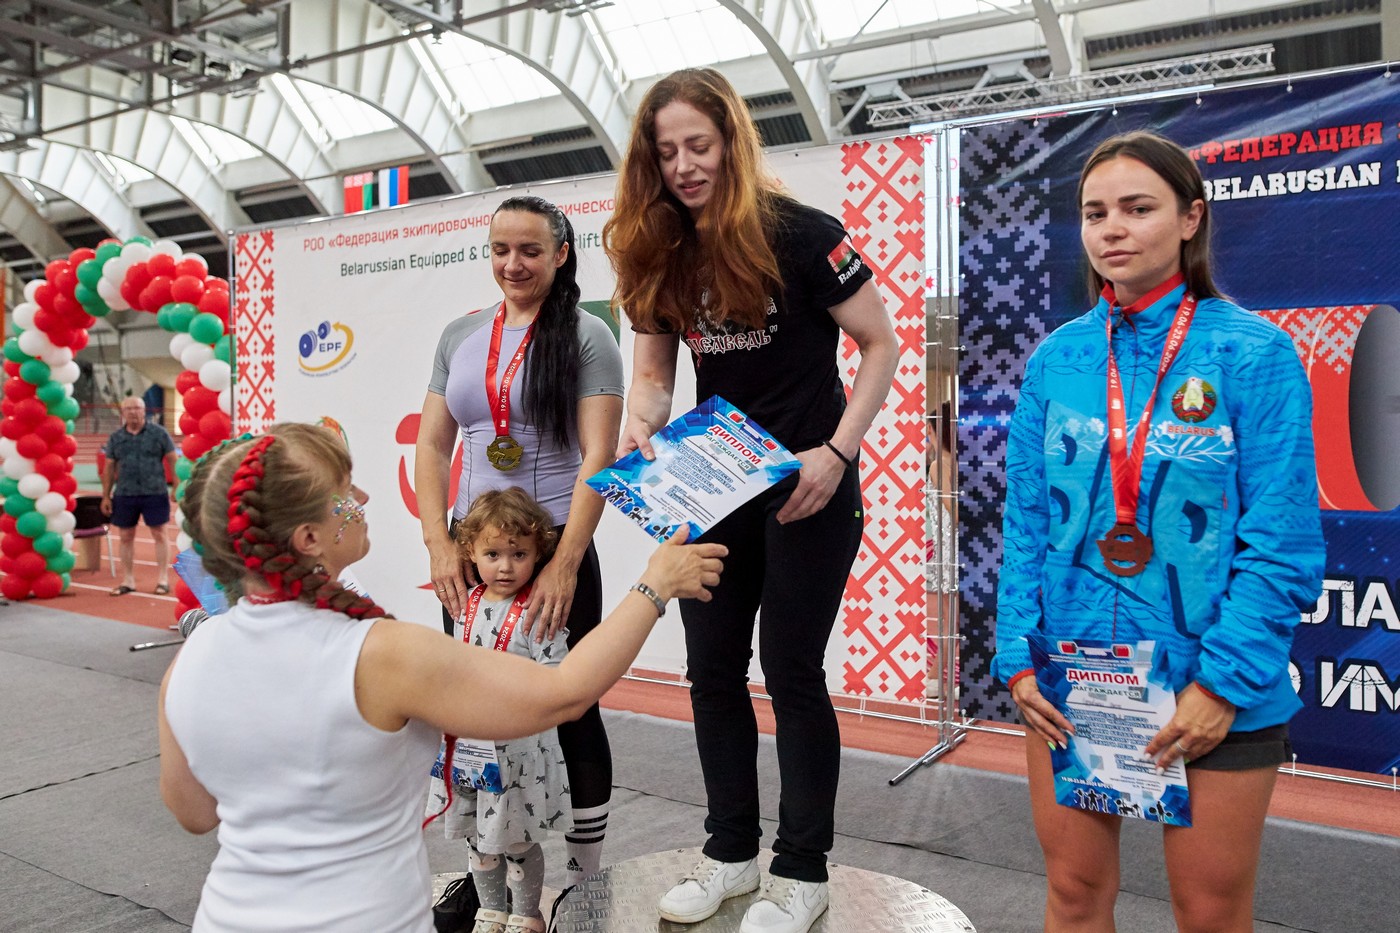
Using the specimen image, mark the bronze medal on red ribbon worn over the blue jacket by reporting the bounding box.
[1098,273,1196,577]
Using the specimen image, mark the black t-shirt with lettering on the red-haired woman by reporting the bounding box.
[649,199,871,451]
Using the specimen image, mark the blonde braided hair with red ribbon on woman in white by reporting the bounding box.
[183,423,386,619]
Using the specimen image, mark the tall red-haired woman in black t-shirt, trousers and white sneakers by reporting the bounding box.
[603,69,899,933]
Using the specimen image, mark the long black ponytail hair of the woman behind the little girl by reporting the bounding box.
[493,195,582,447]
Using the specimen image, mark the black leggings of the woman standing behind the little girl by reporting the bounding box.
[442,520,612,810]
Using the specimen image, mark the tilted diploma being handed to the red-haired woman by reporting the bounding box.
[584,395,802,541]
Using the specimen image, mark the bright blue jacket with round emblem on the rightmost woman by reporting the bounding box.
[993,286,1323,731]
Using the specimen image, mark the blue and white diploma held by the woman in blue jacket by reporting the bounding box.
[1026,633,1191,827]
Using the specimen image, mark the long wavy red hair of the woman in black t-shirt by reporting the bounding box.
[603,69,783,332]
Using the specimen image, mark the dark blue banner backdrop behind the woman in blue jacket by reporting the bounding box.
[958,69,1400,773]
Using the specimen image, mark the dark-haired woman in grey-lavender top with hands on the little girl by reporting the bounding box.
[414,196,623,884]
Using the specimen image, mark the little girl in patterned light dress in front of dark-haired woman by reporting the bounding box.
[428,488,570,933]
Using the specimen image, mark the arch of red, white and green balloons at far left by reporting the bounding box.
[0,237,232,614]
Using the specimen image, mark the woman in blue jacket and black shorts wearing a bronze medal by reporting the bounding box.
[994,133,1323,932]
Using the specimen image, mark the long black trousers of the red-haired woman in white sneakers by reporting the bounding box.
[680,467,864,881]
